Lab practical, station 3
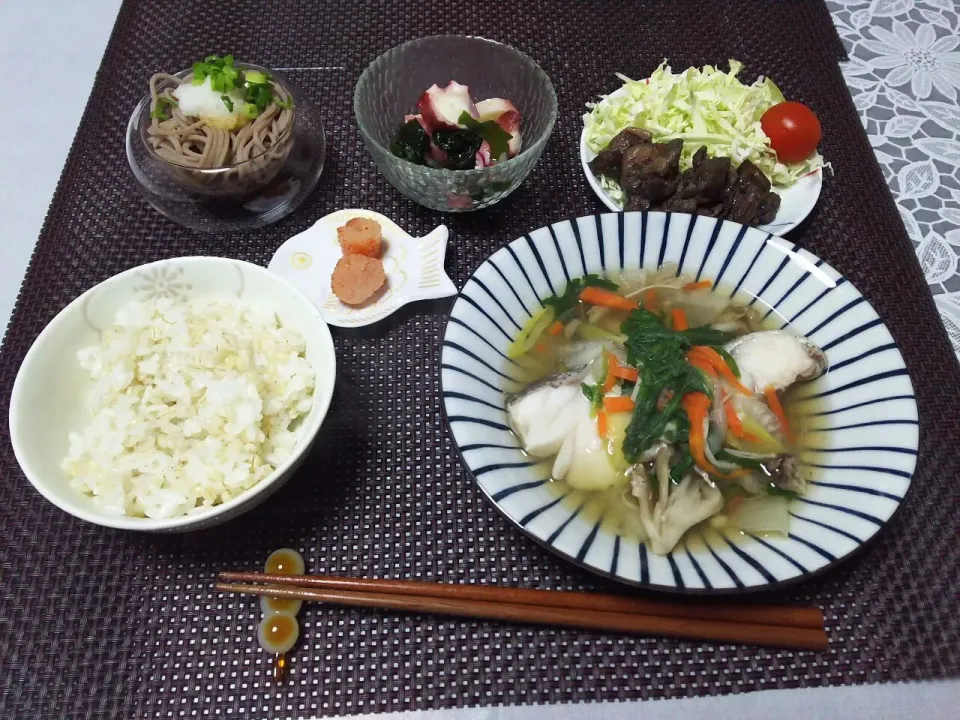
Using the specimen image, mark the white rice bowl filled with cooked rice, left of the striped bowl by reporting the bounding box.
[10,257,336,531]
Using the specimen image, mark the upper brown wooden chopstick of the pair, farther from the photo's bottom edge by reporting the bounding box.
[219,571,823,630]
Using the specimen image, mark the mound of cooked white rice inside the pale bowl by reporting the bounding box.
[62,298,315,518]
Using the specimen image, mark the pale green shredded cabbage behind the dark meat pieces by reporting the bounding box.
[583,60,823,193]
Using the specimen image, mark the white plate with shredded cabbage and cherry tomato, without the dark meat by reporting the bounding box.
[580,60,824,235]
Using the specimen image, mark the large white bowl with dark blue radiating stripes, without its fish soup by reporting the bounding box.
[441,212,918,593]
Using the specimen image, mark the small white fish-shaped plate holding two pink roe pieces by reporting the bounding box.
[267,209,457,327]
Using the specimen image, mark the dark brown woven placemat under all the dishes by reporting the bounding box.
[0,0,960,719]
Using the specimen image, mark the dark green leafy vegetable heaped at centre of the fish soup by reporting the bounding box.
[620,308,732,462]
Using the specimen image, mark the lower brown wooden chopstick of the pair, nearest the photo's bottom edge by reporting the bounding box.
[215,573,827,650]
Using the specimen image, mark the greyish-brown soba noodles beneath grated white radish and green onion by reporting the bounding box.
[147,73,294,192]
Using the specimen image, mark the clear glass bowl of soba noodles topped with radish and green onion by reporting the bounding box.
[126,55,325,232]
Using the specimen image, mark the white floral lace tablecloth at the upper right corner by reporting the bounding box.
[827,0,960,358]
